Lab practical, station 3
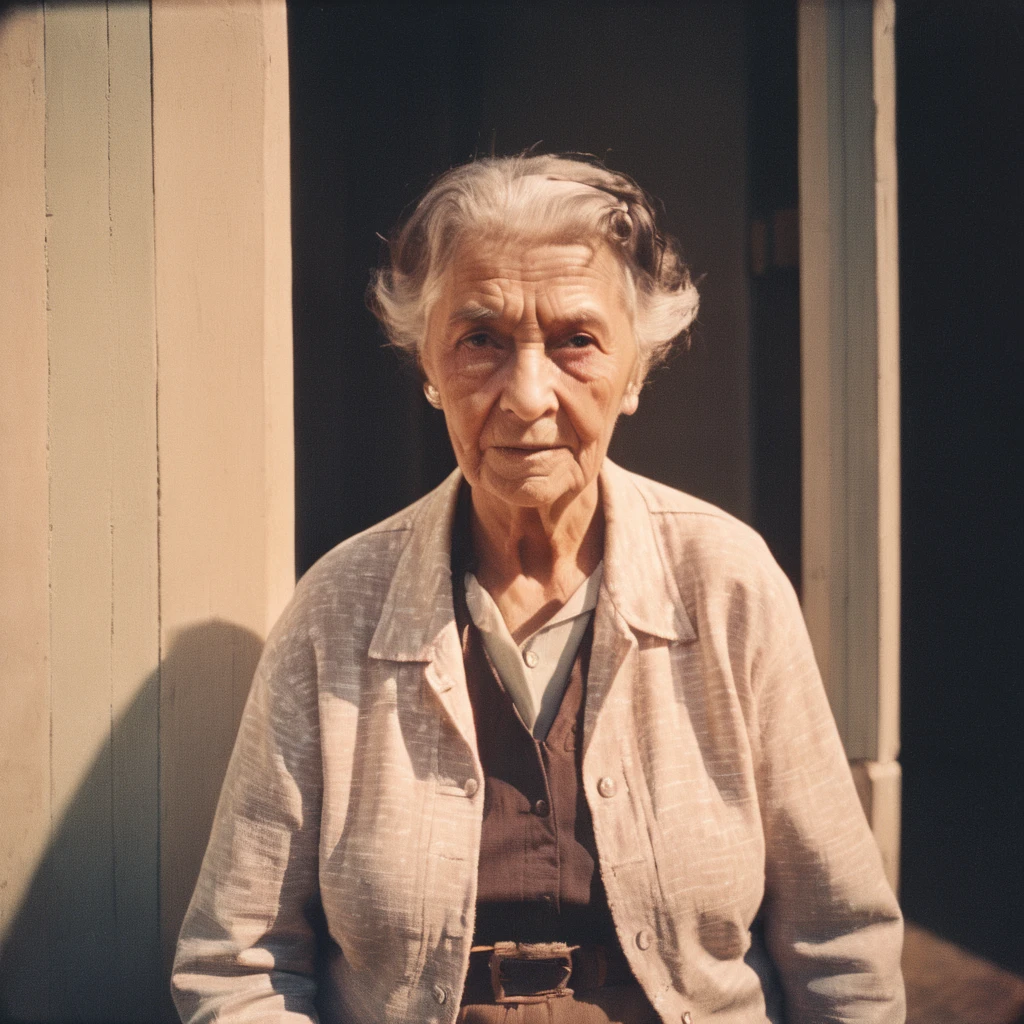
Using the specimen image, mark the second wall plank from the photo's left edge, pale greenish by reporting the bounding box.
[46,5,115,1007]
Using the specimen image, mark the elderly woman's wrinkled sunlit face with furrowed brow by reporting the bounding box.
[422,241,637,509]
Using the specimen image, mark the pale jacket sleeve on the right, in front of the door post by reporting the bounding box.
[753,563,905,1024]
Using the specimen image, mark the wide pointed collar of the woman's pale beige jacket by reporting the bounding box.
[369,459,696,662]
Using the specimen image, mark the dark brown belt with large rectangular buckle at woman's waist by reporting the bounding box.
[463,942,635,1004]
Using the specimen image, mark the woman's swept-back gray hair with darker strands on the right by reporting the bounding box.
[368,156,698,381]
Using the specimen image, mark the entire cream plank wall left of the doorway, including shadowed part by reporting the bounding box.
[0,0,294,1021]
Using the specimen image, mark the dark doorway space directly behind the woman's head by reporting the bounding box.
[289,2,774,572]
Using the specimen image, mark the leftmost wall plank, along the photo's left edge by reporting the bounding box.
[0,6,50,1017]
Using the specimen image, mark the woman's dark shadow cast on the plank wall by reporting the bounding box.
[0,621,263,1024]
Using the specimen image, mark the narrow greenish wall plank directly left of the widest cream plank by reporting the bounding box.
[108,0,166,1021]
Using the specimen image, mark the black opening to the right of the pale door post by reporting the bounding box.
[896,0,1024,973]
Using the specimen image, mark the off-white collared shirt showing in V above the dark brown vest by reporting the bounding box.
[465,562,604,739]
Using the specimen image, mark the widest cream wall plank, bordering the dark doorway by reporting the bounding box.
[153,0,294,978]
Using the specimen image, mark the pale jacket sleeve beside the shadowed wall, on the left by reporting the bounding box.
[171,604,322,1024]
